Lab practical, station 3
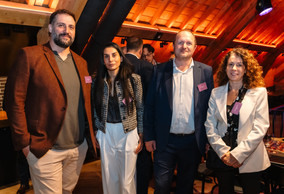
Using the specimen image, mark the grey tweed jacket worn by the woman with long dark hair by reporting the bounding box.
[92,74,143,133]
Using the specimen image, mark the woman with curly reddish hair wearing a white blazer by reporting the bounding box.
[205,48,270,194]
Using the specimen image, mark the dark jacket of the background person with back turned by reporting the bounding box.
[125,54,153,99]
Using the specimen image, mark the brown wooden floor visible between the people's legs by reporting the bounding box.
[0,160,218,194]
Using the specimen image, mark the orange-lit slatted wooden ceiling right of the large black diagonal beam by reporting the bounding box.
[118,0,284,64]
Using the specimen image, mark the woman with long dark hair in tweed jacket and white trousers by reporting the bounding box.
[92,42,143,194]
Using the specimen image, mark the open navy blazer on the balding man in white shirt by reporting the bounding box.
[144,61,214,154]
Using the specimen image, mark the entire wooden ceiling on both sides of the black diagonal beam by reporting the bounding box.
[0,0,284,93]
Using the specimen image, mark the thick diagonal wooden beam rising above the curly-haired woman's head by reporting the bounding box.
[198,0,257,70]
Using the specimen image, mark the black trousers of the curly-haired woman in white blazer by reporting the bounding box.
[215,169,262,194]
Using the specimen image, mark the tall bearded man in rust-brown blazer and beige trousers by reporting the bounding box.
[5,10,96,194]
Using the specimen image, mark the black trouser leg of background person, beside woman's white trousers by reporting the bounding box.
[136,145,153,194]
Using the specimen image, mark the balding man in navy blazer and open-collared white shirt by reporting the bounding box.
[144,30,213,194]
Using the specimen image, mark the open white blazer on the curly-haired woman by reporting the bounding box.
[205,84,270,173]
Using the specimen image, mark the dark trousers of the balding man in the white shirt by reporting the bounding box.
[154,134,201,194]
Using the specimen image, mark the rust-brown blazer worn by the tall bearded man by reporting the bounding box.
[5,43,95,158]
